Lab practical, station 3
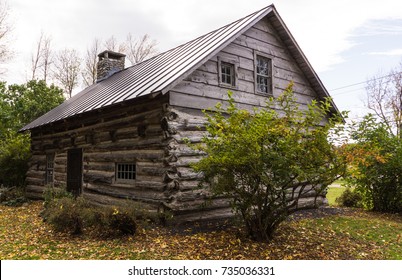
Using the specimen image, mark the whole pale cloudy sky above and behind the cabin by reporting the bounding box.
[2,0,402,118]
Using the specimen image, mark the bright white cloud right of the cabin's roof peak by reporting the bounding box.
[277,0,402,72]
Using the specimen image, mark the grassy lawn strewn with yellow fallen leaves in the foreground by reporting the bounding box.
[0,202,402,260]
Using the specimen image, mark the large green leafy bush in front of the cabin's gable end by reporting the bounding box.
[193,84,346,241]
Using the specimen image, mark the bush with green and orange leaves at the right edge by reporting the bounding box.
[339,115,402,212]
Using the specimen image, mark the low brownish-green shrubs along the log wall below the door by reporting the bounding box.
[41,186,170,236]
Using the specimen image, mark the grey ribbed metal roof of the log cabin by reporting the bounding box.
[20,5,338,131]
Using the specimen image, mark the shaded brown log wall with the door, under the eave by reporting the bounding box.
[27,96,169,211]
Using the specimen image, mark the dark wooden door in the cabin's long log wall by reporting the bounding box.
[67,149,82,196]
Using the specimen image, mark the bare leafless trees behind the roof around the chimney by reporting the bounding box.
[29,32,157,98]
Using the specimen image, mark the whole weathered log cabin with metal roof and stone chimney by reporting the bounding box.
[21,5,337,221]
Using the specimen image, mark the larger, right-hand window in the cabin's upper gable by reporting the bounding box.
[255,55,272,94]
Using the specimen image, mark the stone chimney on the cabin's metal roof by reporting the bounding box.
[96,51,126,83]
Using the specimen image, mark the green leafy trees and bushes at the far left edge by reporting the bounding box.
[0,80,64,187]
